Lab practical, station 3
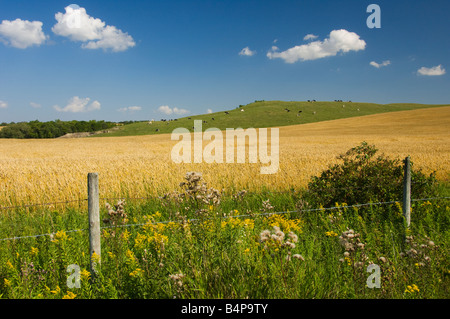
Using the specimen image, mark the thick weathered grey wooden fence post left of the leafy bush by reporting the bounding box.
[88,173,101,274]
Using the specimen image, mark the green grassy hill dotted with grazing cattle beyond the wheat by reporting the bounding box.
[96,101,444,137]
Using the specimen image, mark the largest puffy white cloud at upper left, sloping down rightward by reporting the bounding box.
[52,5,136,52]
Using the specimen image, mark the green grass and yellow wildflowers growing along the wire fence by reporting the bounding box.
[0,143,450,299]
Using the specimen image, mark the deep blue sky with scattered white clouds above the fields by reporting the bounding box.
[0,0,450,122]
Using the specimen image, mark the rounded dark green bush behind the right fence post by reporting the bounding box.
[308,142,436,207]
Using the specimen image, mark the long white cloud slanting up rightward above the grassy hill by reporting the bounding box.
[267,29,366,63]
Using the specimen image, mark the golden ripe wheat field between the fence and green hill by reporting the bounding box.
[0,106,450,206]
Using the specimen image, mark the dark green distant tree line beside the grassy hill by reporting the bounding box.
[0,120,116,138]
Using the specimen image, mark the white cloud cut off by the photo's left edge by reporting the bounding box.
[0,19,47,49]
